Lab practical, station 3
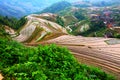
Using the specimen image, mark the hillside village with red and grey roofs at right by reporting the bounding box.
[88,6,120,37]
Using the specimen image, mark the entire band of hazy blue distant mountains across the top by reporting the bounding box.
[0,0,120,18]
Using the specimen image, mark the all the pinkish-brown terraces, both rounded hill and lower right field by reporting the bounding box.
[3,15,120,80]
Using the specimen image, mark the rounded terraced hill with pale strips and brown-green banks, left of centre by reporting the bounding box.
[14,13,67,43]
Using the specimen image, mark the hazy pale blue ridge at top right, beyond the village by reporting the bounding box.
[72,0,120,8]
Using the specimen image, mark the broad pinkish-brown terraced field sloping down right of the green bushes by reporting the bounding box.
[39,35,120,80]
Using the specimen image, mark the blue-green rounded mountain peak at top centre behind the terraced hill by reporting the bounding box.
[40,1,71,13]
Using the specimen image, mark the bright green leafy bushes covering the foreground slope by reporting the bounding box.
[0,39,115,80]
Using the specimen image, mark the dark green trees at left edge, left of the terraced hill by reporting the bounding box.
[0,16,27,30]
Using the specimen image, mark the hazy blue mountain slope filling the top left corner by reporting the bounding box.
[0,0,65,18]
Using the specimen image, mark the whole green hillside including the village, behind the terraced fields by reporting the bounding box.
[57,3,120,38]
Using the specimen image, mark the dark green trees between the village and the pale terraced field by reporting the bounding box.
[78,20,120,38]
